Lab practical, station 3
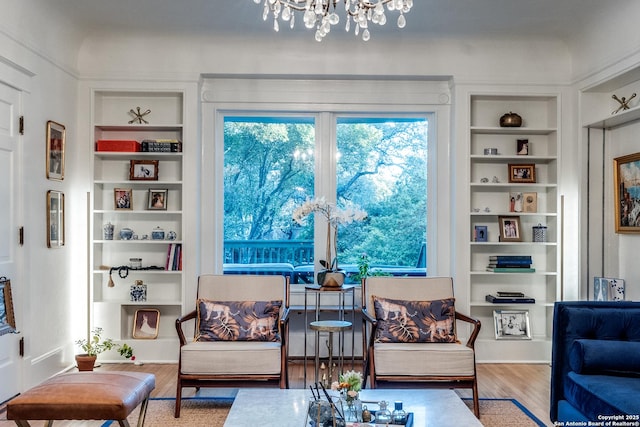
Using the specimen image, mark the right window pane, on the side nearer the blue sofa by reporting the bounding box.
[336,117,428,275]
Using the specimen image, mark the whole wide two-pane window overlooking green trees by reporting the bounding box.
[224,114,428,283]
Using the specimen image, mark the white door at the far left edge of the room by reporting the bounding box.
[0,83,22,402]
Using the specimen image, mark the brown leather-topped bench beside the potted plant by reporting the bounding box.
[7,371,156,427]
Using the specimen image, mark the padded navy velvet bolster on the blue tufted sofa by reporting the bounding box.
[569,339,640,376]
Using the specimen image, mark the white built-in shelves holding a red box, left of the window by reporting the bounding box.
[90,90,189,361]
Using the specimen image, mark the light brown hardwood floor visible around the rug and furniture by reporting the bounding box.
[97,361,553,426]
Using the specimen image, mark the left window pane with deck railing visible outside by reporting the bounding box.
[224,116,315,278]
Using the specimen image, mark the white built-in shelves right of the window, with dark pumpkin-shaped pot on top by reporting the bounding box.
[468,94,561,362]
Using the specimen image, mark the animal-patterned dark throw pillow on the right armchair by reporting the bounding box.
[373,295,457,343]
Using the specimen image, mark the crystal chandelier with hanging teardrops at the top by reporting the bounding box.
[253,0,413,42]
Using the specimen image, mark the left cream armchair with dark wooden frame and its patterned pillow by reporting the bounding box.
[175,275,289,418]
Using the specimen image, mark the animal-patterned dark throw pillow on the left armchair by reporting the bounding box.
[195,299,282,341]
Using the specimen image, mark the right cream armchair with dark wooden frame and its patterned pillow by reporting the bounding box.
[362,277,480,417]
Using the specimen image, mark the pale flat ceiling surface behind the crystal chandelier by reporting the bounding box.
[56,0,616,43]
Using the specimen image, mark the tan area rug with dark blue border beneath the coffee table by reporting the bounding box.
[102,397,545,427]
